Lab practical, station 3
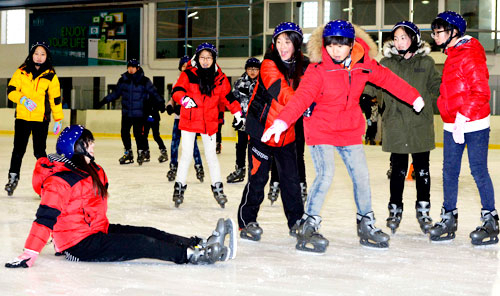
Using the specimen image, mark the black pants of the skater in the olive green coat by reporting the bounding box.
[390,151,431,206]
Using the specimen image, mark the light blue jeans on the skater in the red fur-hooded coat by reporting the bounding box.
[306,145,372,215]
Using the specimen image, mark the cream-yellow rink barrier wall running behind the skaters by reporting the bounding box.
[0,108,500,149]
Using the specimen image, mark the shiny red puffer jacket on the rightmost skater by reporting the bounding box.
[437,36,490,123]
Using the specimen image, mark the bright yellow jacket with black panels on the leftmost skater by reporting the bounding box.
[7,67,64,121]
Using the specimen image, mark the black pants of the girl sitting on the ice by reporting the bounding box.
[64,224,199,264]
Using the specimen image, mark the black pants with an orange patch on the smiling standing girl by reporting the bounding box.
[238,138,304,228]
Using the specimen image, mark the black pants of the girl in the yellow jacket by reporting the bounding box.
[9,119,49,175]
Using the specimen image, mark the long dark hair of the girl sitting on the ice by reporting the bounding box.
[71,129,108,198]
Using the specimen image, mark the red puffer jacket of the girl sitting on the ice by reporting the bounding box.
[24,155,109,252]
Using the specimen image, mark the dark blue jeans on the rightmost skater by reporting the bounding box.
[443,128,495,211]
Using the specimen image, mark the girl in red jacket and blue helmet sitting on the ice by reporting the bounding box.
[5,125,236,268]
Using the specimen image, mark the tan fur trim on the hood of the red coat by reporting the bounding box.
[307,25,378,63]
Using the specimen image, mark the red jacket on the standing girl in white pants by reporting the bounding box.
[172,67,241,136]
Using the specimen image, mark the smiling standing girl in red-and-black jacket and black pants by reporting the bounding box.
[238,22,308,241]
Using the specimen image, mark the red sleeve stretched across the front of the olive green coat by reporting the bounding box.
[369,61,420,105]
